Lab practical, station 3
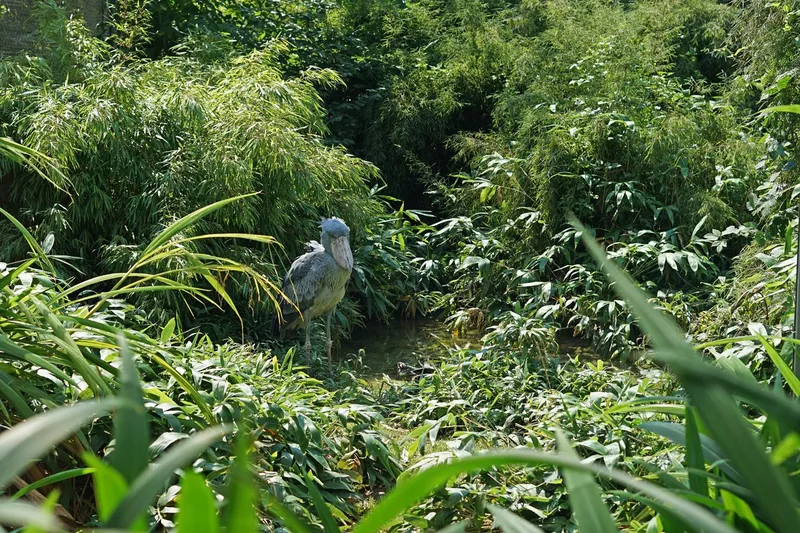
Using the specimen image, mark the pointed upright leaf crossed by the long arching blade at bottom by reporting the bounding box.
[556,430,619,533]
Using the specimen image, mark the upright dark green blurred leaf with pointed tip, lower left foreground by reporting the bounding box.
[109,333,150,485]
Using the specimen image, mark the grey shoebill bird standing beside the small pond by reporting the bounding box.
[281,217,353,371]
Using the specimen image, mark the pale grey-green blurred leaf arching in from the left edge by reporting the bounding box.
[0,398,121,488]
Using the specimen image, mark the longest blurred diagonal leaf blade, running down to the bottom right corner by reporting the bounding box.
[573,215,800,533]
